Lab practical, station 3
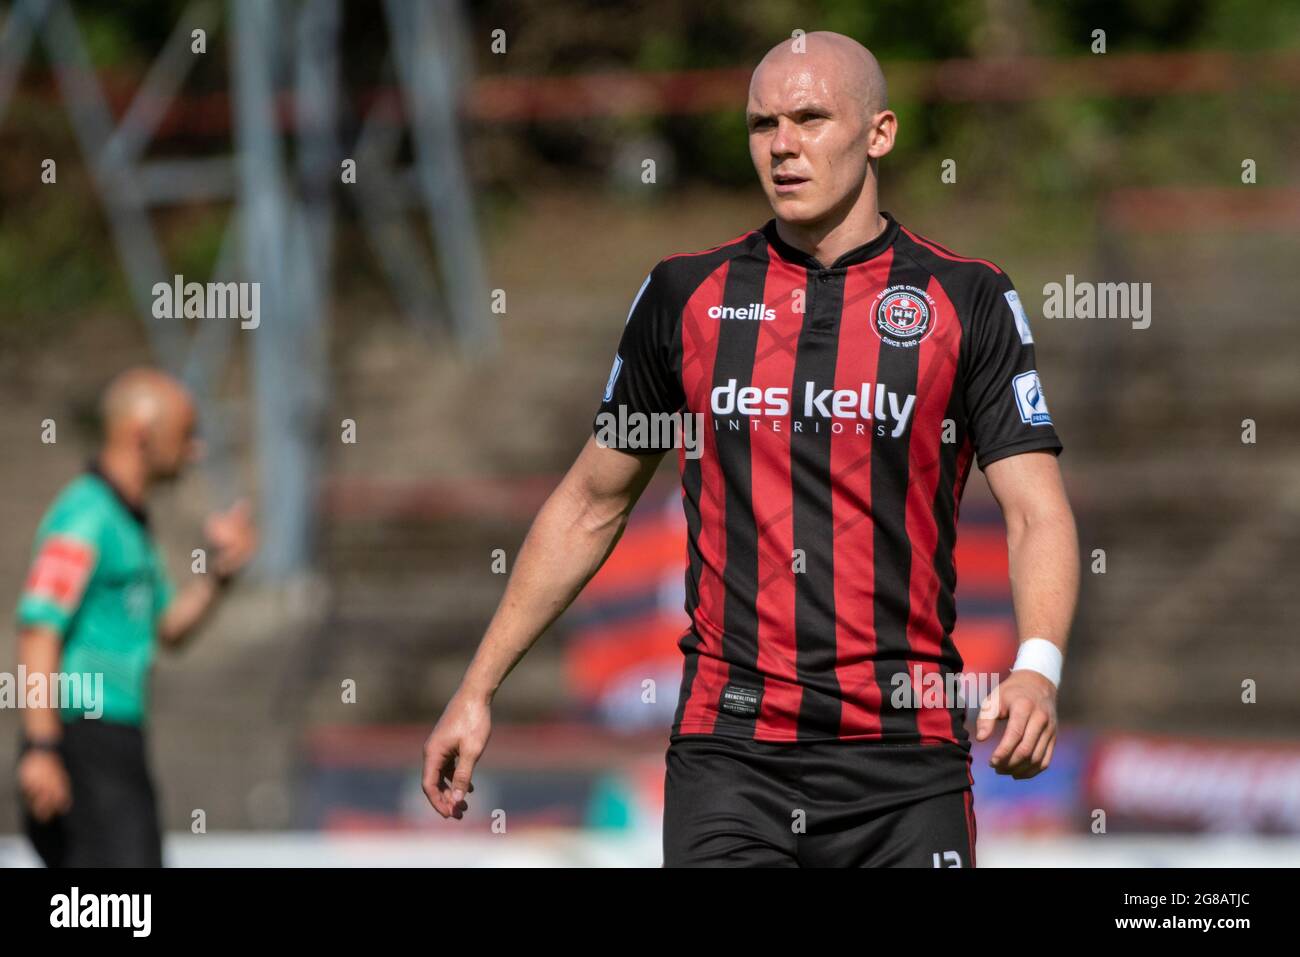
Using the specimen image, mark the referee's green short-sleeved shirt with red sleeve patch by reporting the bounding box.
[18,465,173,726]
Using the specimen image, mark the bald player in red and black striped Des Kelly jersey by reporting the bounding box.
[424,33,1078,867]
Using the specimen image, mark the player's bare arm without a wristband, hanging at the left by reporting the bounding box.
[424,438,663,818]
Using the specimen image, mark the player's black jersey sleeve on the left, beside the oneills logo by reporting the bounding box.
[592,264,685,454]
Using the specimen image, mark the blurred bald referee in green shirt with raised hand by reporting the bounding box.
[18,369,256,867]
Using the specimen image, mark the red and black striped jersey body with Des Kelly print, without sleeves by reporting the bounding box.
[644,210,1029,749]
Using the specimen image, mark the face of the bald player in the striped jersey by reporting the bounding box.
[746,57,870,225]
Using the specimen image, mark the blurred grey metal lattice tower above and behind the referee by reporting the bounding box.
[0,0,495,580]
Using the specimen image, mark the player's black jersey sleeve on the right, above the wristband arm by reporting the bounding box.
[966,273,1062,469]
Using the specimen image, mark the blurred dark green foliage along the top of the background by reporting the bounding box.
[0,0,1300,342]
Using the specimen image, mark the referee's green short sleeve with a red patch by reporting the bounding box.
[17,511,100,637]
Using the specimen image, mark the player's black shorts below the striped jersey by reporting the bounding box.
[663,735,975,867]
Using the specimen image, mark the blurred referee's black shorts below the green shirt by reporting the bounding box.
[22,719,163,867]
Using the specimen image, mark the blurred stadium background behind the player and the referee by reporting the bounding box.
[0,0,1300,866]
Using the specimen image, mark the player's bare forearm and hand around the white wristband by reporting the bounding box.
[975,452,1079,779]
